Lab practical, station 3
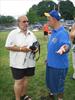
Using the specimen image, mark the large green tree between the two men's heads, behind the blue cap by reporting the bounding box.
[27,1,55,23]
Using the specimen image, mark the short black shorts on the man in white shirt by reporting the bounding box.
[11,67,35,80]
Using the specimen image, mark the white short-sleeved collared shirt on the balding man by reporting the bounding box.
[5,28,37,69]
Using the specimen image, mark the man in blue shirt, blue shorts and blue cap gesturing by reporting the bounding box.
[44,10,70,100]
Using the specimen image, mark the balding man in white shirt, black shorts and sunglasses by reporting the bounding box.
[5,16,37,100]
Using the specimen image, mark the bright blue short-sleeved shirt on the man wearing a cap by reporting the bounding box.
[47,26,70,68]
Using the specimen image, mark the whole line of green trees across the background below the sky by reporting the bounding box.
[0,0,75,26]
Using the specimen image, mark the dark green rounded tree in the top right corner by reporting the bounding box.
[60,0,74,20]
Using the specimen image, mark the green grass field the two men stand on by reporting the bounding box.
[0,31,75,100]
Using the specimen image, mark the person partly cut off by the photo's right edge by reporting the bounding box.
[70,23,75,80]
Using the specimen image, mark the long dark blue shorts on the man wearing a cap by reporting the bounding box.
[46,66,68,94]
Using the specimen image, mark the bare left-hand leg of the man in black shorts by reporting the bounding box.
[14,78,27,100]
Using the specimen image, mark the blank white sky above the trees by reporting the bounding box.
[0,0,75,18]
